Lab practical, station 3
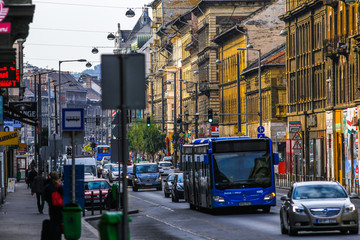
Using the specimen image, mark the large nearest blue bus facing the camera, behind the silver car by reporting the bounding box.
[181,137,279,212]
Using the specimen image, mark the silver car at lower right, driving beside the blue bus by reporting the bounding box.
[280,181,359,235]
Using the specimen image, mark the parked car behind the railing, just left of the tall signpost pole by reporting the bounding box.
[84,177,110,206]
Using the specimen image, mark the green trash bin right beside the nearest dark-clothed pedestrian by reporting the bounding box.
[63,203,81,240]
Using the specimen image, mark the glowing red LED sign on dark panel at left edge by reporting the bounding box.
[0,62,20,88]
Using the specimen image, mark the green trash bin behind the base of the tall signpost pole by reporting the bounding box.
[99,212,131,240]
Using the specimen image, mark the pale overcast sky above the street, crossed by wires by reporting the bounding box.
[24,0,152,72]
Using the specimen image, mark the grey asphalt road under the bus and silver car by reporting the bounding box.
[90,185,360,240]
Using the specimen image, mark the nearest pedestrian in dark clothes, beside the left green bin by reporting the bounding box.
[45,172,64,240]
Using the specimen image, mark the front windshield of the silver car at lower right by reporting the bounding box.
[293,185,347,199]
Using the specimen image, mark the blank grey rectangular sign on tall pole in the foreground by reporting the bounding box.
[101,54,145,240]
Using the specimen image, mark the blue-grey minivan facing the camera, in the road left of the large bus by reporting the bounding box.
[131,163,162,192]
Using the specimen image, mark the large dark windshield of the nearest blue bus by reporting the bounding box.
[214,151,271,190]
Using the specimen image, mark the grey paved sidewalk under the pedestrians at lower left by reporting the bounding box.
[0,182,100,240]
